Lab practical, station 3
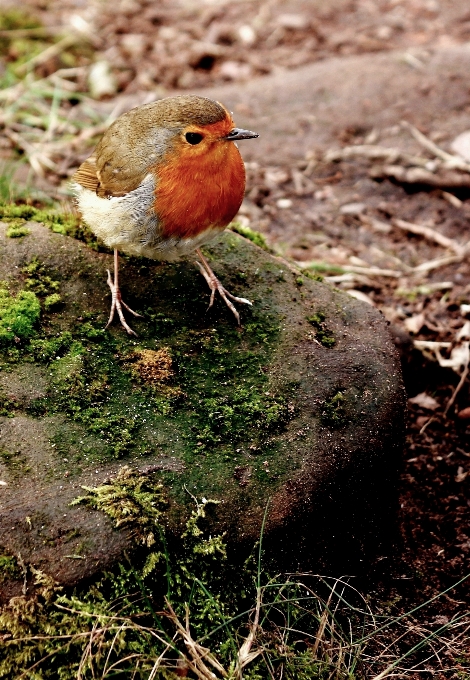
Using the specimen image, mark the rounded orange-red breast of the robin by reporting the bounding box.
[154,141,245,238]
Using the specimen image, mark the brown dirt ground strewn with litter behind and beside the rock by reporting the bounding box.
[2,0,470,678]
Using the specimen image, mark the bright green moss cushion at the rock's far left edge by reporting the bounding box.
[0,287,41,346]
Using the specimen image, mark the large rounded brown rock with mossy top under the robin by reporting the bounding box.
[0,222,404,583]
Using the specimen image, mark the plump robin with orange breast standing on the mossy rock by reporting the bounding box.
[72,94,259,335]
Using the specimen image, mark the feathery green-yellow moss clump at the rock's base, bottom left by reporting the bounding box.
[0,468,235,680]
